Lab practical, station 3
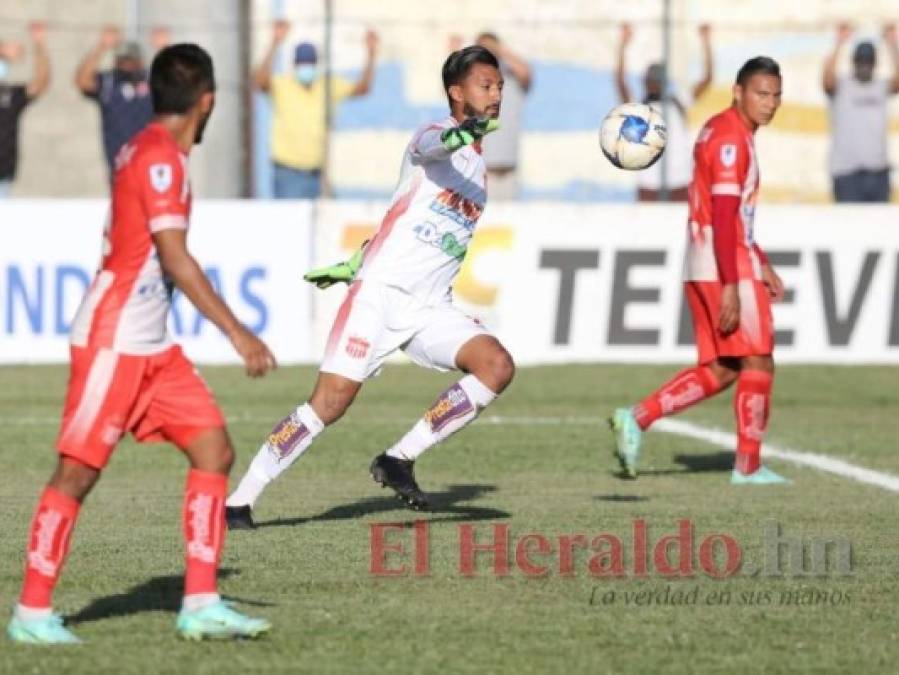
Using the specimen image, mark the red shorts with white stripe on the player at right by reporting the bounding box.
[684,279,774,364]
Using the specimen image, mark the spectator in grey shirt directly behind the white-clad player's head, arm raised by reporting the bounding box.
[476,33,531,201]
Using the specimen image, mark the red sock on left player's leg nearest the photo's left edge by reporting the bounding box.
[19,487,81,609]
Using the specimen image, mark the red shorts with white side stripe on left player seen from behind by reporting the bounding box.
[56,346,225,469]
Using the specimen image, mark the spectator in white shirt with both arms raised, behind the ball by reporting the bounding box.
[615,24,714,202]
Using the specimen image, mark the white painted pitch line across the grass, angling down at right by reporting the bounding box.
[0,415,899,492]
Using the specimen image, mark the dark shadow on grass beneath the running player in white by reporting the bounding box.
[256,485,511,528]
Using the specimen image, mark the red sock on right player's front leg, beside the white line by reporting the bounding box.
[734,370,774,474]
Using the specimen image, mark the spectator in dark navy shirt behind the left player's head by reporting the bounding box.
[75,26,169,179]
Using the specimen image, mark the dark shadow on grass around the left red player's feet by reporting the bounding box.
[65,567,274,625]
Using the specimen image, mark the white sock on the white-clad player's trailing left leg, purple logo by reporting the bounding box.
[225,403,325,507]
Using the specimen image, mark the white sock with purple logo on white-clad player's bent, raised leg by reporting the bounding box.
[387,375,496,461]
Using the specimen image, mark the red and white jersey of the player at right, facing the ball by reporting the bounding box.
[684,108,761,281]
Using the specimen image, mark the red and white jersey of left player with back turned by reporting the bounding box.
[71,123,191,355]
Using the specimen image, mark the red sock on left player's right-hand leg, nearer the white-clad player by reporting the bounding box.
[184,469,228,595]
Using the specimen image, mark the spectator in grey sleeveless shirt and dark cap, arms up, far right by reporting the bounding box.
[824,24,899,202]
